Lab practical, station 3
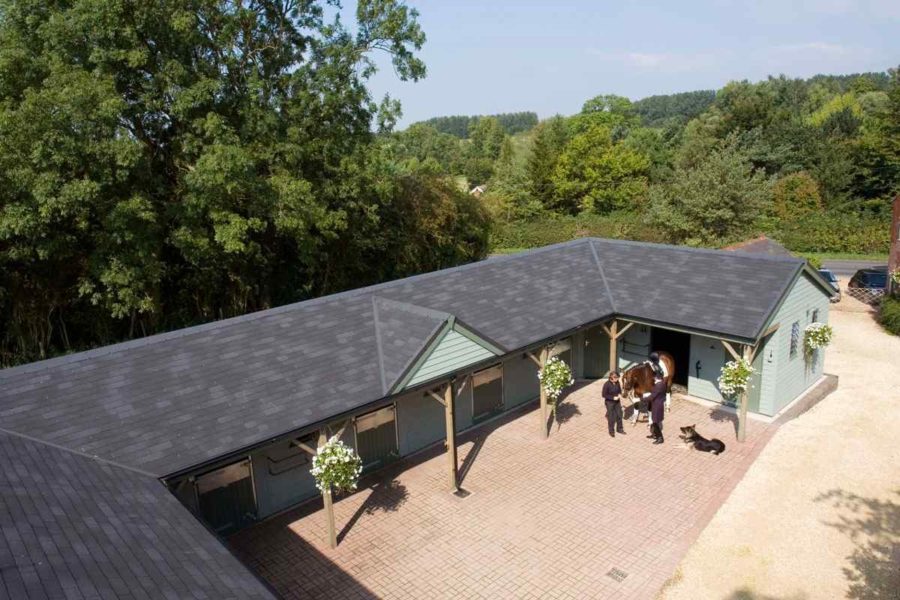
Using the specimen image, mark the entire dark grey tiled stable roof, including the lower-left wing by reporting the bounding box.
[0,239,816,597]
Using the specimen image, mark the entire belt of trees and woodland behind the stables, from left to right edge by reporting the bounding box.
[0,0,900,366]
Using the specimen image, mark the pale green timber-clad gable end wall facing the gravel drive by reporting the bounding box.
[759,273,829,415]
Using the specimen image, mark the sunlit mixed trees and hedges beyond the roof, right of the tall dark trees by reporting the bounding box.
[472,69,900,254]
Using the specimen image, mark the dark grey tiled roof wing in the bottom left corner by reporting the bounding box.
[0,432,274,599]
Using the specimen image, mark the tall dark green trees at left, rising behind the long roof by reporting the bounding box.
[0,0,489,364]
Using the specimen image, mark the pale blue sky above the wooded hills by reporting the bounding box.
[362,0,900,126]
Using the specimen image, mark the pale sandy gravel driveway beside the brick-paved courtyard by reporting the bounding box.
[661,308,900,600]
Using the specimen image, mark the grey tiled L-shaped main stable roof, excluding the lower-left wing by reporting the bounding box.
[0,239,802,477]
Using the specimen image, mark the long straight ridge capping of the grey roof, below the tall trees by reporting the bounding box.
[0,238,590,379]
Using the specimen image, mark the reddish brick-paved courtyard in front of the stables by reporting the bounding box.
[230,382,775,599]
